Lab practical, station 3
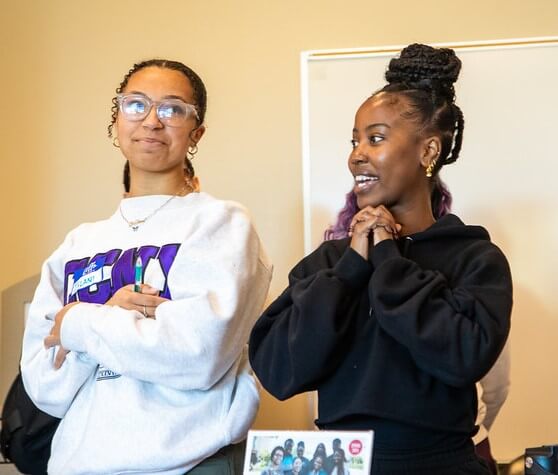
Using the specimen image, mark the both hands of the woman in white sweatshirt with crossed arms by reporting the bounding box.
[43,284,168,369]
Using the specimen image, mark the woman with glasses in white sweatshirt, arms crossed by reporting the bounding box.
[21,60,271,475]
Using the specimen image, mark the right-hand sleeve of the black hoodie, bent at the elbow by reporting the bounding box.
[369,240,512,387]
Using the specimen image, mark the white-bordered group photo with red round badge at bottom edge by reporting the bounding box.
[243,430,374,475]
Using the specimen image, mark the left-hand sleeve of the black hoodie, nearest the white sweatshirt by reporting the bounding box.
[249,243,371,400]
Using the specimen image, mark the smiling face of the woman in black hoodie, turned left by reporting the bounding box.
[349,93,434,210]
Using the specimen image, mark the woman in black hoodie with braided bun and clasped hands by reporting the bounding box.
[250,44,512,475]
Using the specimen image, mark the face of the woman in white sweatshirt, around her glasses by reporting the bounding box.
[116,66,204,178]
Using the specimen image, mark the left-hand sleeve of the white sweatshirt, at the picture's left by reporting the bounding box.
[21,229,97,417]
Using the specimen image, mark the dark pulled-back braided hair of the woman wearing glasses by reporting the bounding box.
[107,59,207,193]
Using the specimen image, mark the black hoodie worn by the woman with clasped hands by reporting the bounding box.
[249,215,512,452]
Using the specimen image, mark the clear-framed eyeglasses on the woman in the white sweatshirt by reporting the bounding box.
[116,94,199,127]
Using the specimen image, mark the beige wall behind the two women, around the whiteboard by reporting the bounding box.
[0,0,558,457]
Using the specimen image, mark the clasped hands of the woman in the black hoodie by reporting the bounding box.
[349,205,401,259]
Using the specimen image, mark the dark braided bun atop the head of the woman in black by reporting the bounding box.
[386,43,461,101]
